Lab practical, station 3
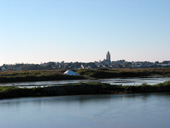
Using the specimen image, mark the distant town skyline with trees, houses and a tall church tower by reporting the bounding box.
[0,51,170,71]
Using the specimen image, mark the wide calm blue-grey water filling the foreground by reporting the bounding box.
[0,93,170,128]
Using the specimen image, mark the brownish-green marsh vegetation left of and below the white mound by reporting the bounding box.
[0,70,84,83]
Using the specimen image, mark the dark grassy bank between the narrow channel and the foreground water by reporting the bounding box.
[0,82,170,99]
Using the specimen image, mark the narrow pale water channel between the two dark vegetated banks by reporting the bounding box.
[0,77,170,87]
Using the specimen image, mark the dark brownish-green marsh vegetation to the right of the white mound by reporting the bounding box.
[77,68,170,78]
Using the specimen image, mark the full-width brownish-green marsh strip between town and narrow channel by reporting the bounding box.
[0,68,170,83]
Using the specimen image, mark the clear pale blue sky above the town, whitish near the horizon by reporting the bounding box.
[0,0,170,65]
